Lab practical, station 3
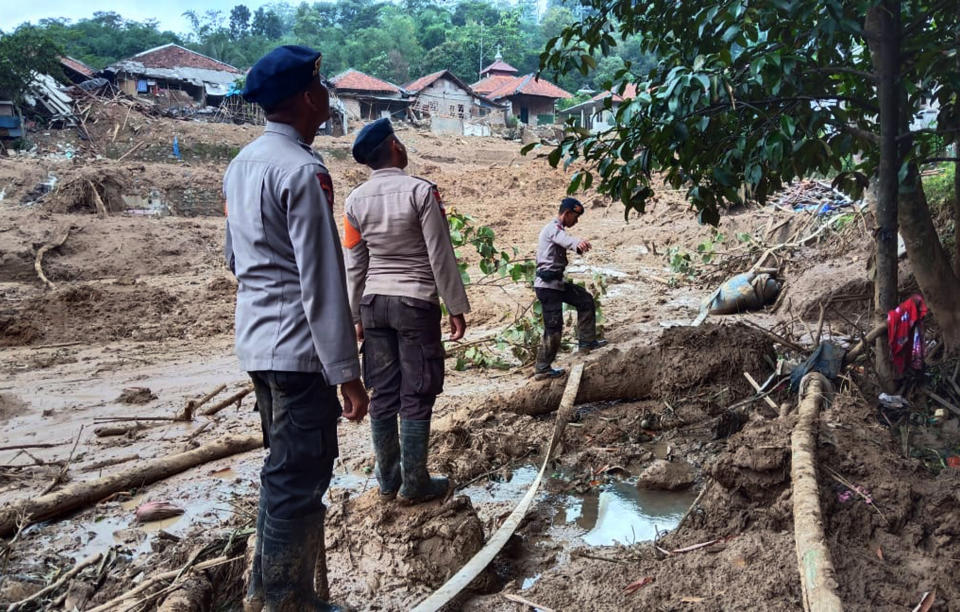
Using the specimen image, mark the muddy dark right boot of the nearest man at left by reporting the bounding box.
[261,512,341,612]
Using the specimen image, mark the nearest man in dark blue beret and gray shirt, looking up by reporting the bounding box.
[223,46,368,612]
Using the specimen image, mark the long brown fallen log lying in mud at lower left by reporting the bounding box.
[0,434,263,537]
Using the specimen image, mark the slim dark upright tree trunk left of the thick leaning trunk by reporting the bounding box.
[864,0,901,392]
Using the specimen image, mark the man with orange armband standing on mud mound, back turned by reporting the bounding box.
[343,119,470,504]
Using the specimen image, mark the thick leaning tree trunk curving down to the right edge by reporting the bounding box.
[900,164,960,351]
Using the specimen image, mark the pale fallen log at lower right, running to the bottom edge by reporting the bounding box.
[790,373,843,612]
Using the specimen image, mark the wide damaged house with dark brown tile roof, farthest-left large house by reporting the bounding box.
[102,43,243,106]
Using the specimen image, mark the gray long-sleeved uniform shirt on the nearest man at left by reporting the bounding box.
[223,122,360,385]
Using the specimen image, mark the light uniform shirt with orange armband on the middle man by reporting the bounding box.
[343,168,470,321]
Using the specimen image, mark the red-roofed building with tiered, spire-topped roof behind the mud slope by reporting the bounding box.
[470,51,573,126]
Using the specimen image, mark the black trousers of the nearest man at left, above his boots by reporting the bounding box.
[248,371,342,519]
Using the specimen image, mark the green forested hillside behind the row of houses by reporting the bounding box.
[20,0,652,91]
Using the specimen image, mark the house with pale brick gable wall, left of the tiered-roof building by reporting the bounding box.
[403,70,506,134]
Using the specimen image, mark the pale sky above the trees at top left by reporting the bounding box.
[0,0,280,33]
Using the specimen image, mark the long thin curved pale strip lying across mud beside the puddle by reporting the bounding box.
[413,363,583,612]
